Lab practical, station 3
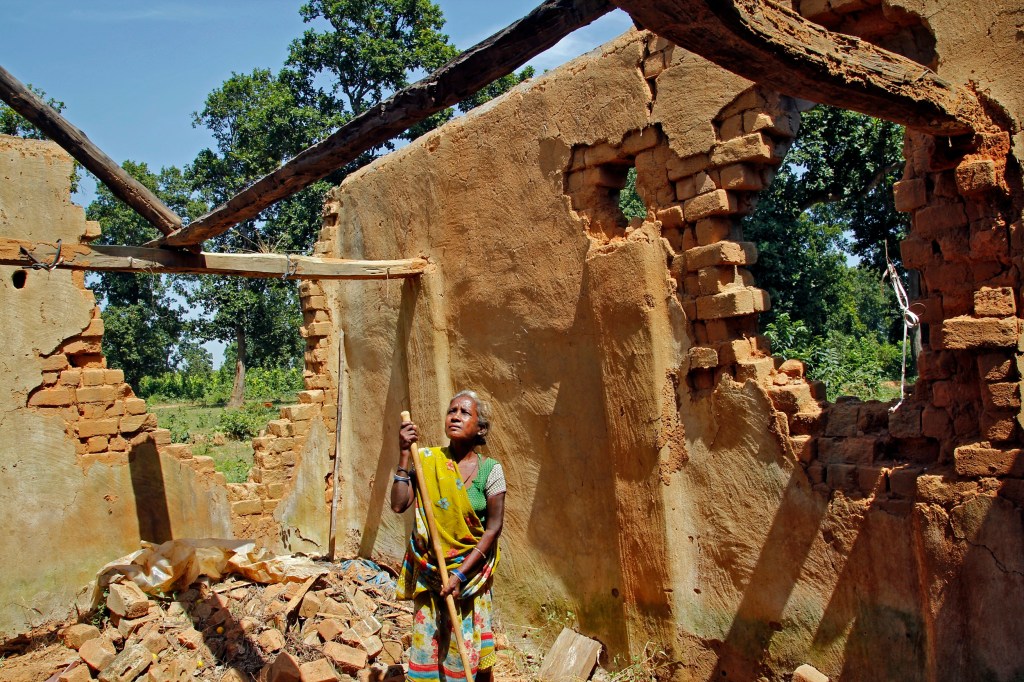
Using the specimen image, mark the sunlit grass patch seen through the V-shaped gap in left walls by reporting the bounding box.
[148,393,288,483]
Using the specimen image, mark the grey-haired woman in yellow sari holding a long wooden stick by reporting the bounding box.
[391,391,505,682]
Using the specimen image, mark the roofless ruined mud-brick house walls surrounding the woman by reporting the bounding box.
[0,0,1024,680]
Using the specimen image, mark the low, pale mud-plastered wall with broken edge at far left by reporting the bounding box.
[0,136,230,639]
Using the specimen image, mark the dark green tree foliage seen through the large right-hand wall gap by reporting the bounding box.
[743,105,907,339]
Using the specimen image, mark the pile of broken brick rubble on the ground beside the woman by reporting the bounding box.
[6,560,425,682]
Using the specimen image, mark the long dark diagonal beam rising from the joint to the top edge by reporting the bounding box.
[154,0,613,247]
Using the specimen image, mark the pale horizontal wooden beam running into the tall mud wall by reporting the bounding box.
[0,238,427,280]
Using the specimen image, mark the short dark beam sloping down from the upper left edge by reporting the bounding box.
[0,67,181,235]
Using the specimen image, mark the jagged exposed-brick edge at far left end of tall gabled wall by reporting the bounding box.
[227,223,338,524]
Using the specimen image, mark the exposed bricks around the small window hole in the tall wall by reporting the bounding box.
[565,36,800,390]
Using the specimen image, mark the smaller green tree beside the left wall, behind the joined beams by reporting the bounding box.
[86,161,203,391]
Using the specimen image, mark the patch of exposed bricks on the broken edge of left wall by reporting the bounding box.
[28,273,224,483]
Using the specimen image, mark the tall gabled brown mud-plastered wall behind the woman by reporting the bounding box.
[319,19,1024,680]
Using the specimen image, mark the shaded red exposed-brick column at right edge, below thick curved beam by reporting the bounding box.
[896,123,1024,450]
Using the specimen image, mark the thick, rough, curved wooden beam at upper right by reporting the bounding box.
[613,0,981,135]
